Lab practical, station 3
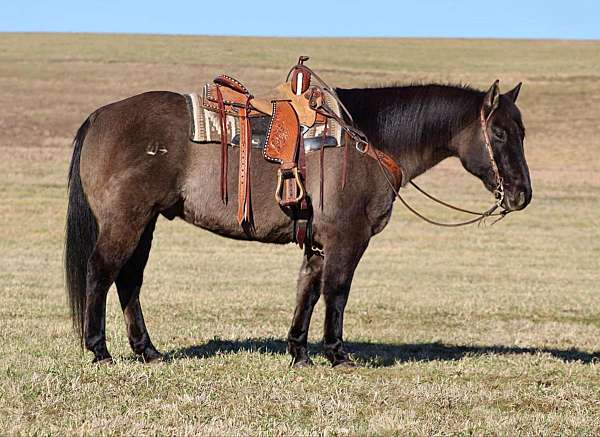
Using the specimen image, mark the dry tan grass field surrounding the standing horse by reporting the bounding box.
[0,34,600,435]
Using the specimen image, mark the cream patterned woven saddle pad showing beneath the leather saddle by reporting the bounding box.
[183,93,344,147]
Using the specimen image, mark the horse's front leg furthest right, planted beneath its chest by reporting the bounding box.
[321,240,368,366]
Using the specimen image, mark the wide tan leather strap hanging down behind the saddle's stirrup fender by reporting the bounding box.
[237,106,253,226]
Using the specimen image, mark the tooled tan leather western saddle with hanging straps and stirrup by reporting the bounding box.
[200,56,401,255]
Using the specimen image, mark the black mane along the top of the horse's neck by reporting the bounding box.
[336,84,485,152]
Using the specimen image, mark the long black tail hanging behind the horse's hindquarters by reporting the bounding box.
[64,118,98,340]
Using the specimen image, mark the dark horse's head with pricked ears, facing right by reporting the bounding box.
[459,81,532,211]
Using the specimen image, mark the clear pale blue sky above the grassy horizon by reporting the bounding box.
[0,0,600,39]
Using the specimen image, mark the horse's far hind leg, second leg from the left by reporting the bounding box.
[115,217,162,362]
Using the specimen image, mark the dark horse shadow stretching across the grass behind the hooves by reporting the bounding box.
[166,338,600,367]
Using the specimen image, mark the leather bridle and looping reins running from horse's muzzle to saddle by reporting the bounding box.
[304,67,510,228]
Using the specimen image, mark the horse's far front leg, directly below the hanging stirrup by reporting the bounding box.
[288,256,323,367]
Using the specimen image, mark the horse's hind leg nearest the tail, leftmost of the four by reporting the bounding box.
[83,214,154,362]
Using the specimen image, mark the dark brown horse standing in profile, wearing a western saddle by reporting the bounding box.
[65,78,532,365]
